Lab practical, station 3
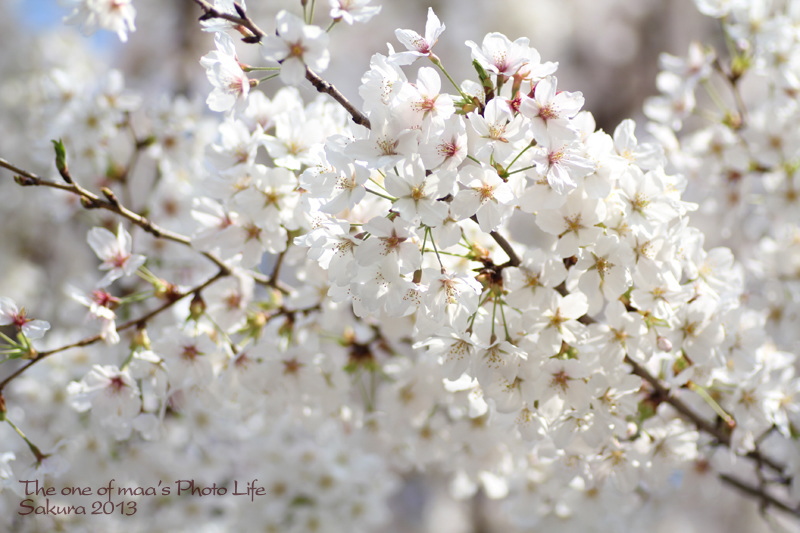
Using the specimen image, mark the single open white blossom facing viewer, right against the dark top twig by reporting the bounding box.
[262,11,330,85]
